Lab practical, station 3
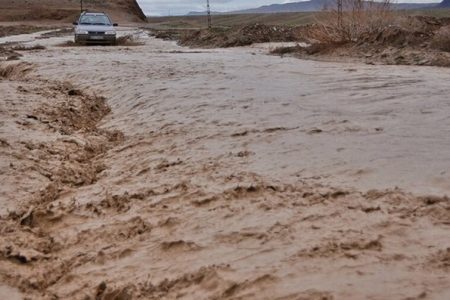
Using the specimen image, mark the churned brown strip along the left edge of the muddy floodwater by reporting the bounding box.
[0,63,122,298]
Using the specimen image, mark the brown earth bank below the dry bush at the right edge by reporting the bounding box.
[272,17,450,67]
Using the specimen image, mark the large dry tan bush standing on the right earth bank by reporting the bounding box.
[312,0,395,43]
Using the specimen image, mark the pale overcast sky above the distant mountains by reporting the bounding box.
[137,0,440,16]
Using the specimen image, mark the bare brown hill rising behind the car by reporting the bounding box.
[0,0,146,22]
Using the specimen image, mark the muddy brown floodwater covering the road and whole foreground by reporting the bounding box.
[0,31,450,299]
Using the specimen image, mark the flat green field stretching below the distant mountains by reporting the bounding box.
[147,9,450,29]
